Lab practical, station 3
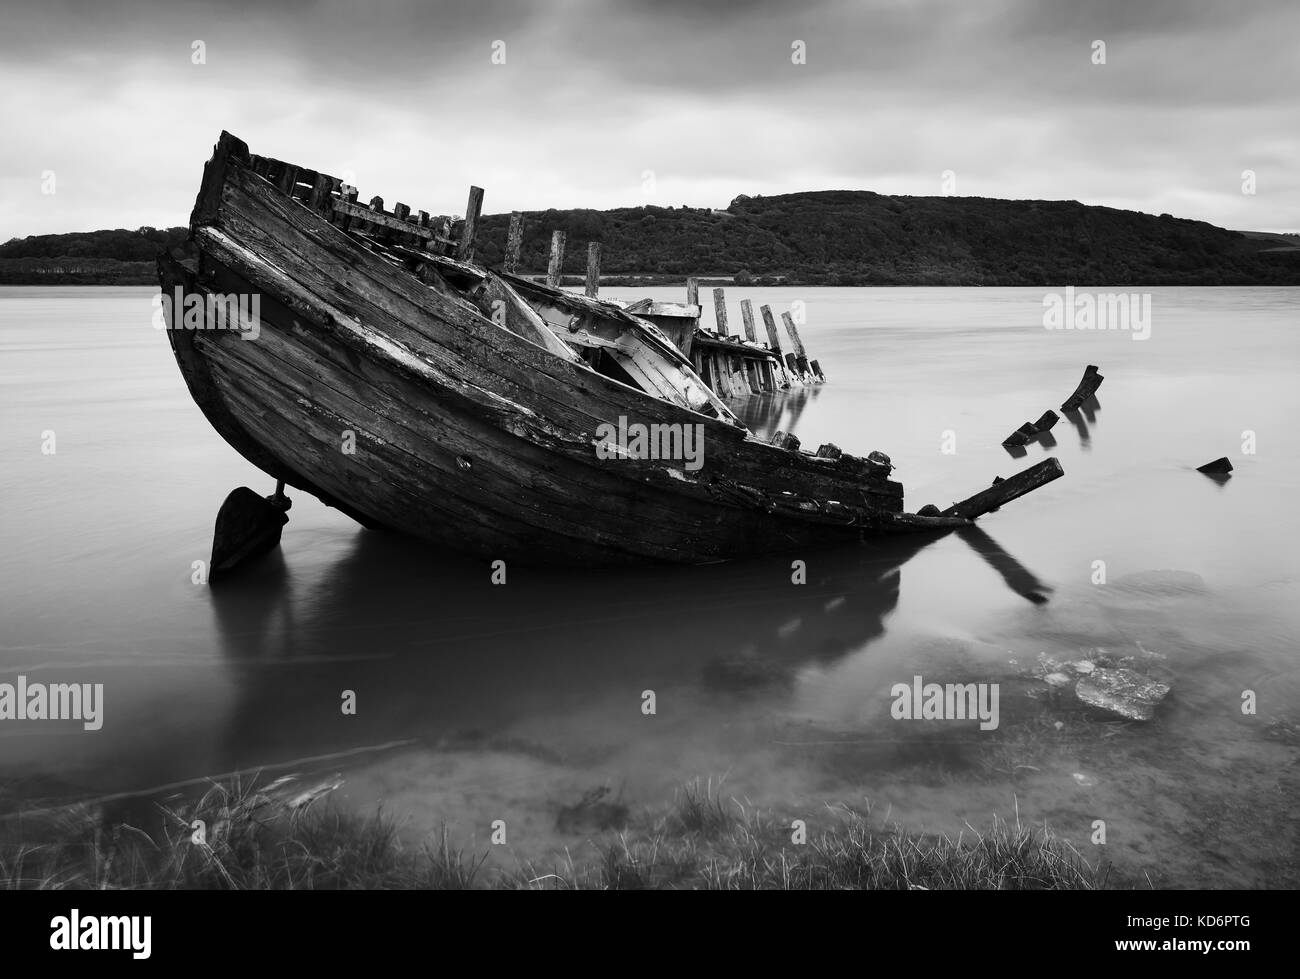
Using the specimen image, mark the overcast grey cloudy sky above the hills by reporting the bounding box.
[0,0,1300,241]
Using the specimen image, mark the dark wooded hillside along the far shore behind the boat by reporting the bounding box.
[0,191,1300,286]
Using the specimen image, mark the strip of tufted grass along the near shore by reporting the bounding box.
[0,780,1108,891]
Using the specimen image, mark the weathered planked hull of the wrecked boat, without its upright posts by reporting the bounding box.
[160,134,1055,564]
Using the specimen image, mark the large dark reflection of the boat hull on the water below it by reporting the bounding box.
[211,532,932,767]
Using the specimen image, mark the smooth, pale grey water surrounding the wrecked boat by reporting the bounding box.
[0,287,1300,887]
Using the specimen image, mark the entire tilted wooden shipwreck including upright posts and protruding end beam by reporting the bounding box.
[159,134,1061,567]
